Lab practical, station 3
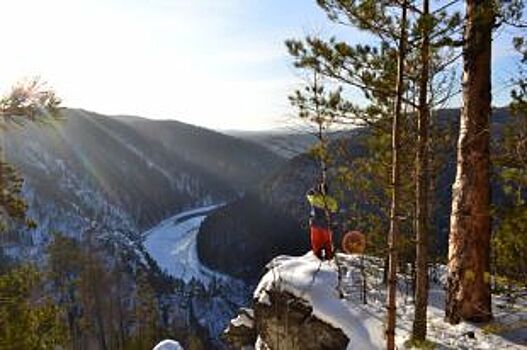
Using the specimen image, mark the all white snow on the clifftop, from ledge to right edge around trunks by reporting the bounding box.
[254,253,527,350]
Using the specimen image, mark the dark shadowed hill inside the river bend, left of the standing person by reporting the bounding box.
[198,129,367,283]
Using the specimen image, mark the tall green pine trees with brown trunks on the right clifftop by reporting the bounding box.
[287,0,527,349]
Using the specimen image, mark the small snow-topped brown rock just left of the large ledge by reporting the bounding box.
[222,308,256,350]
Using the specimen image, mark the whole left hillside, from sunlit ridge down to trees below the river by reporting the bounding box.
[0,109,283,349]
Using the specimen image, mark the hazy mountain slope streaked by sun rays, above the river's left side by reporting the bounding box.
[4,109,284,245]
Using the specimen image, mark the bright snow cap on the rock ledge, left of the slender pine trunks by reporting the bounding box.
[254,252,384,350]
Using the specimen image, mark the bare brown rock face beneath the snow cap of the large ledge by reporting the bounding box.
[254,290,349,350]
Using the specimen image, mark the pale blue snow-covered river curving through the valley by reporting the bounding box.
[143,204,224,284]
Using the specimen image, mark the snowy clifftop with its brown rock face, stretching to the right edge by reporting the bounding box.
[246,253,527,350]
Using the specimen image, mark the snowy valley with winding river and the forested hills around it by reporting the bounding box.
[2,106,524,349]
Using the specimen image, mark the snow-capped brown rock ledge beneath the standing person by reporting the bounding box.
[254,252,384,350]
